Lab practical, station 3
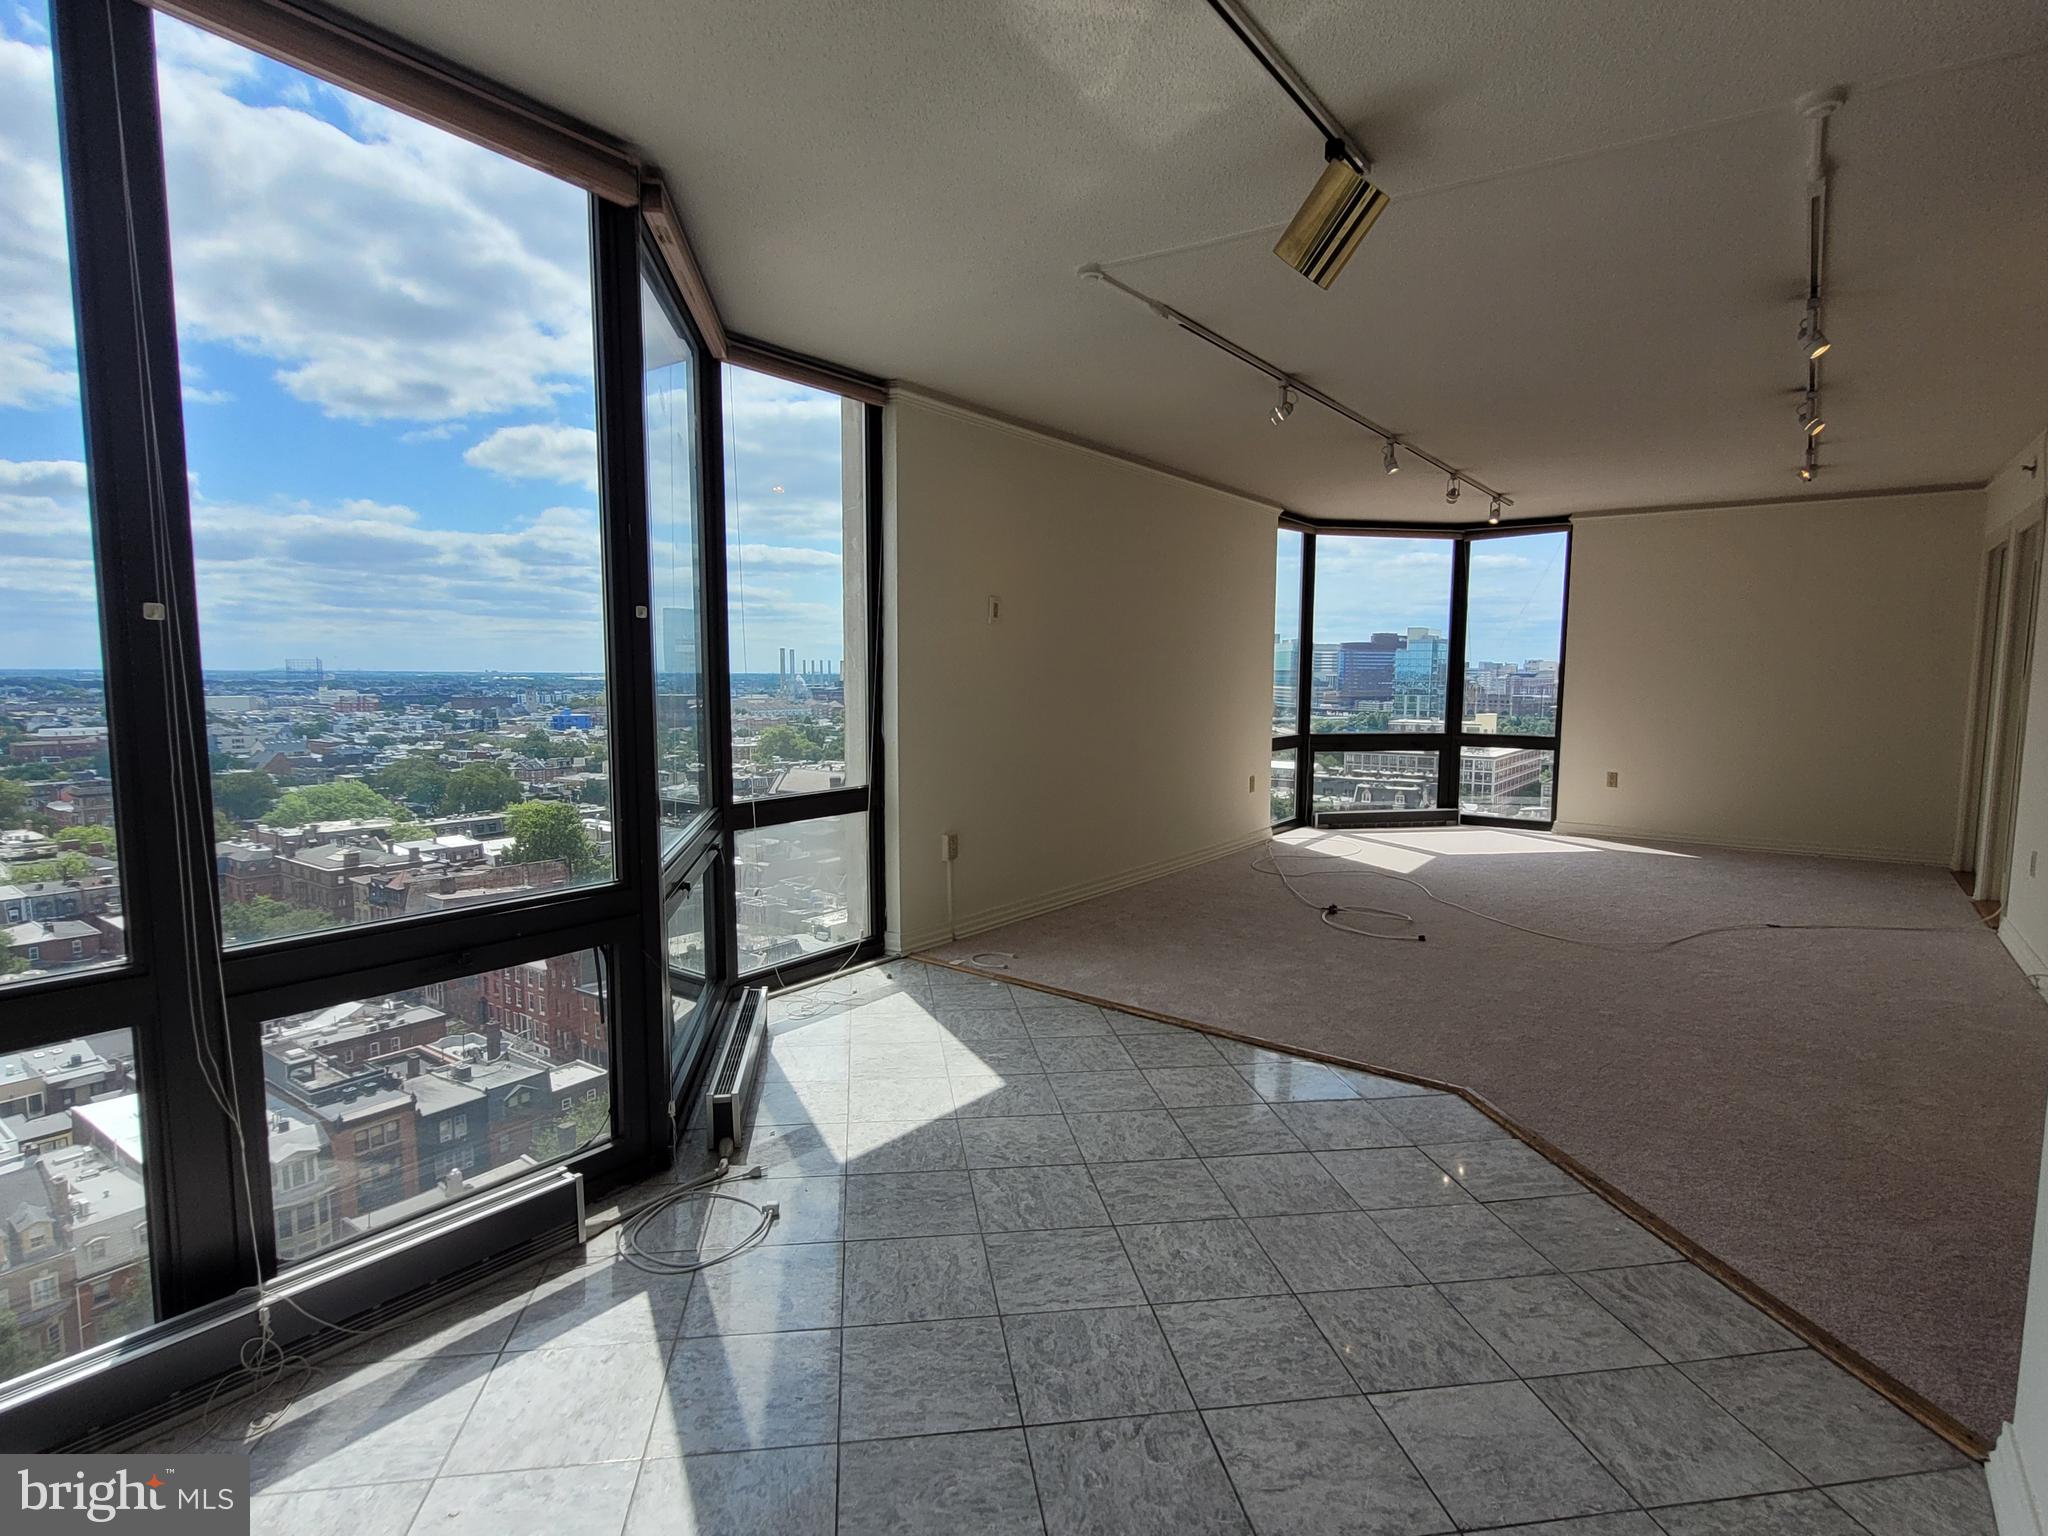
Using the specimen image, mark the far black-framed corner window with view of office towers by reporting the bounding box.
[1272,522,1571,825]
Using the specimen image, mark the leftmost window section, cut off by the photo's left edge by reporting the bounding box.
[0,4,162,1386]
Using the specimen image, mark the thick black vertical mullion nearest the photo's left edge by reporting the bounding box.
[51,2,260,1315]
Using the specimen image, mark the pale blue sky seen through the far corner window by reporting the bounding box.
[1274,532,1565,662]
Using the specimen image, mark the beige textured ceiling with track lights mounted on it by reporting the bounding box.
[335,0,2048,520]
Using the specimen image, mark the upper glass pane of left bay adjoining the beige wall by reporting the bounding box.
[725,367,868,801]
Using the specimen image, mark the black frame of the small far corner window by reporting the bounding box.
[1272,514,1571,831]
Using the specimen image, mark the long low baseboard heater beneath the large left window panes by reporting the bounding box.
[0,1167,586,1452]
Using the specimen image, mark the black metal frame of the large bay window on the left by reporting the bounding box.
[0,0,885,1448]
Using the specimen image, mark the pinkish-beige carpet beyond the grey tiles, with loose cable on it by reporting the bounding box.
[936,827,2048,1440]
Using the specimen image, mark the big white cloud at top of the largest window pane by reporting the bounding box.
[158,16,592,424]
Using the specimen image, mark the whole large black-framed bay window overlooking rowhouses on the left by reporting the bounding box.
[0,0,881,1438]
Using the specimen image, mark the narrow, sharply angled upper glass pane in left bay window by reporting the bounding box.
[641,276,711,850]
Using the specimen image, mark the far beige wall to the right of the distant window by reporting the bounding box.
[1559,492,1985,864]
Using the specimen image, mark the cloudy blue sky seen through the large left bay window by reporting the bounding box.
[0,0,844,672]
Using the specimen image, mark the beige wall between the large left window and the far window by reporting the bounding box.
[883,395,1276,948]
